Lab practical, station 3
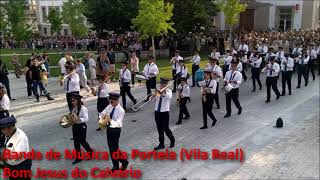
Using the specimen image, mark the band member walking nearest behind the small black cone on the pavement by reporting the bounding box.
[262,56,280,103]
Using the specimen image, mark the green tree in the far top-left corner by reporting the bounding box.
[5,0,32,44]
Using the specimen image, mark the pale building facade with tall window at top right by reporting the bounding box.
[216,0,320,31]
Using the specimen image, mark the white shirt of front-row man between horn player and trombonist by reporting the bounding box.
[99,104,125,128]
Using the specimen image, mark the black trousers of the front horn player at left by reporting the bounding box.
[72,123,92,160]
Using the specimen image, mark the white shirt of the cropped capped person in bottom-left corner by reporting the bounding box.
[5,128,29,166]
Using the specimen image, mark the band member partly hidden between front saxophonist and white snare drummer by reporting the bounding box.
[206,57,222,109]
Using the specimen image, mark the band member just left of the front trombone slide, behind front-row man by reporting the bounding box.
[119,62,137,110]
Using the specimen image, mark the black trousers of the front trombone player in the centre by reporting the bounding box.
[154,111,175,146]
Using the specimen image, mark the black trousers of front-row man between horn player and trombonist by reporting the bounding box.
[107,126,128,169]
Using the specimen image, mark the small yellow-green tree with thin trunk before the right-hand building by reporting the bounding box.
[217,0,247,44]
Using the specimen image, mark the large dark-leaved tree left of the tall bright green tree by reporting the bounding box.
[83,0,138,35]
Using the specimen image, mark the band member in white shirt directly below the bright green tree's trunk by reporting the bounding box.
[143,56,159,102]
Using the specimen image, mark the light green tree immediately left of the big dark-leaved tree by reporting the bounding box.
[61,0,88,37]
